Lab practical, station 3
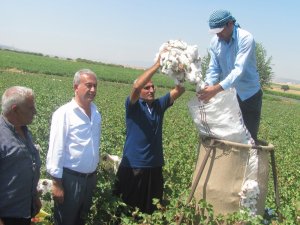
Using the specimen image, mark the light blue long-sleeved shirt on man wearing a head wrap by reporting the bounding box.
[206,26,261,101]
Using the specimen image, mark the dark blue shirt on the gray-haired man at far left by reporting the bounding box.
[0,115,41,218]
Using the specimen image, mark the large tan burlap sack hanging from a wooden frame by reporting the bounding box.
[193,140,269,215]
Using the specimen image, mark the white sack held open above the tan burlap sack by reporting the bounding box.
[188,88,253,144]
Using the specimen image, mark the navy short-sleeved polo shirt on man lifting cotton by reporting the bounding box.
[121,93,171,168]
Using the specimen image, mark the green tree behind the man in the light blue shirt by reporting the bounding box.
[201,43,273,87]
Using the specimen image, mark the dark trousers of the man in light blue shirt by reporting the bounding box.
[237,90,262,141]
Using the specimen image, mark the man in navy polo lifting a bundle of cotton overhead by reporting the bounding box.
[114,55,184,214]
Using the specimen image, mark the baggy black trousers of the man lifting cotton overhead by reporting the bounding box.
[113,166,163,214]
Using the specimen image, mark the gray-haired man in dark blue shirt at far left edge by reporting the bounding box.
[0,86,42,225]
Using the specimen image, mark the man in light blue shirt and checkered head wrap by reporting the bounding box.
[198,10,262,141]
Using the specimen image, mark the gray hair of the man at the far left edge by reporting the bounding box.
[1,86,34,115]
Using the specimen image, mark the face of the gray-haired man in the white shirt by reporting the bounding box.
[74,74,97,104]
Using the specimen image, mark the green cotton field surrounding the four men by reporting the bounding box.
[0,51,300,225]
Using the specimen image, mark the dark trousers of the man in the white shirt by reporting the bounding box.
[54,170,97,225]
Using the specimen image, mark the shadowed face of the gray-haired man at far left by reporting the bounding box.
[15,96,36,126]
